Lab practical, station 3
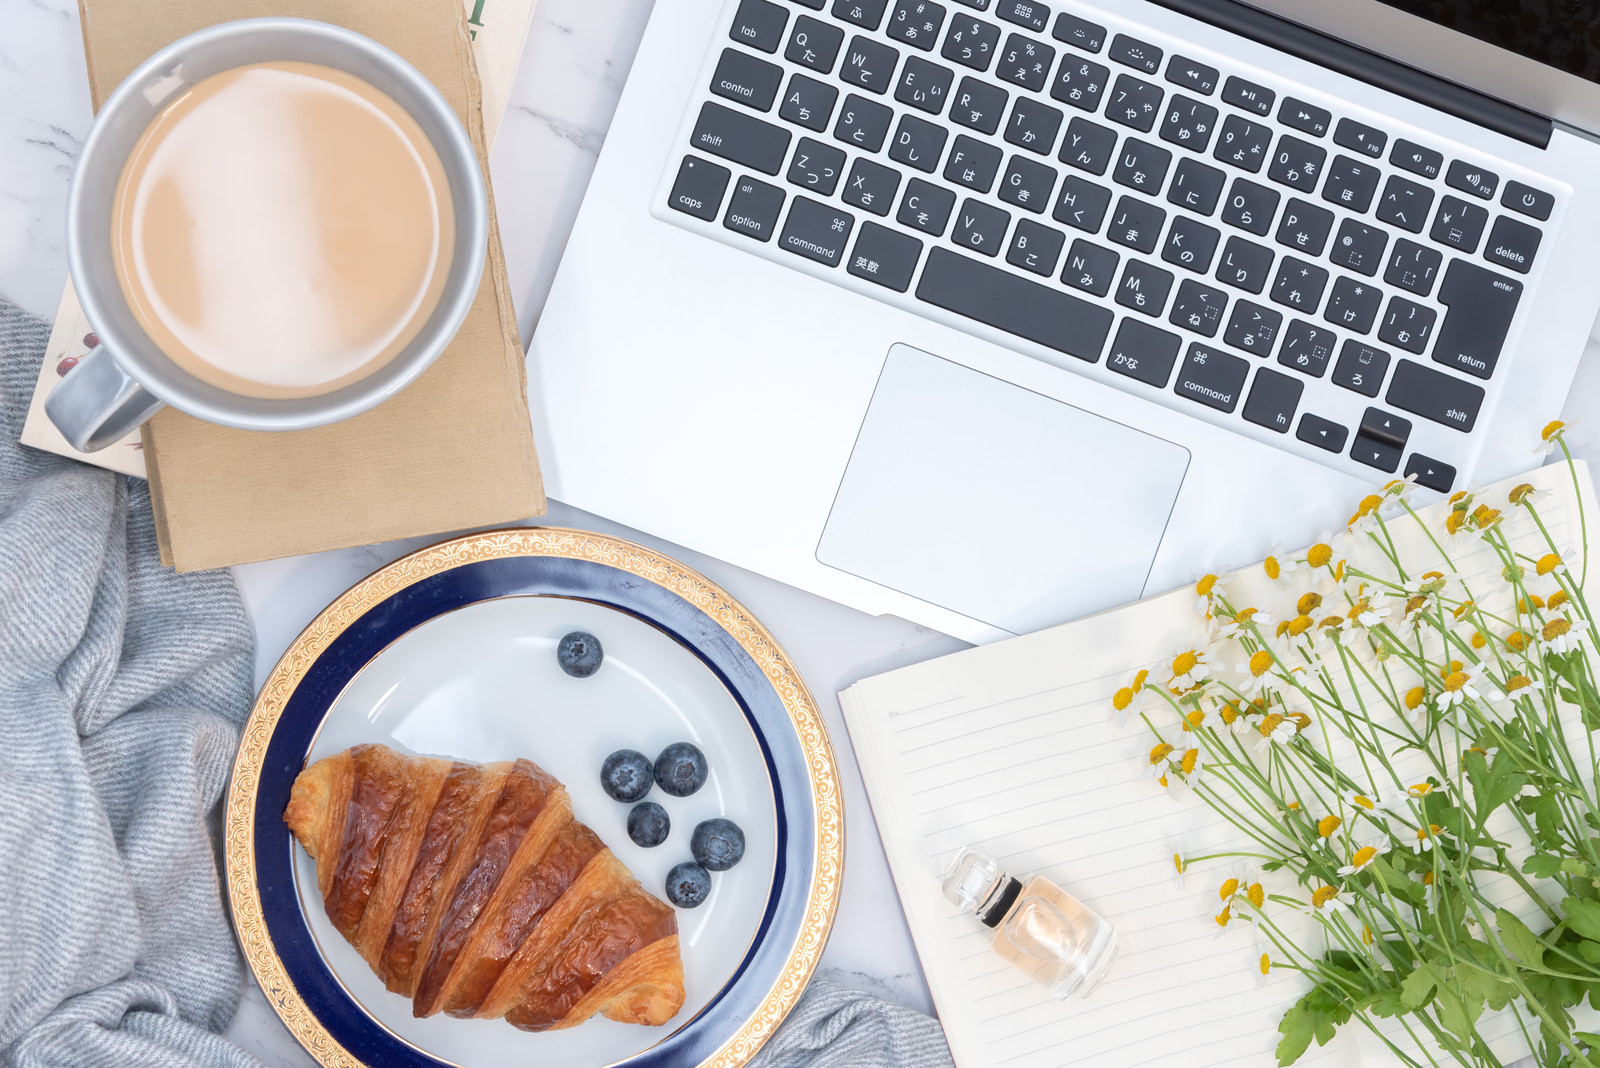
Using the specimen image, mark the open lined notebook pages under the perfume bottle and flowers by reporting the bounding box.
[840,464,1600,1068]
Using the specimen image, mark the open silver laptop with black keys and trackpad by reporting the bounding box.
[528,0,1600,641]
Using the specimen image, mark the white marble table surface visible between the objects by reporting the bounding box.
[9,0,1600,1068]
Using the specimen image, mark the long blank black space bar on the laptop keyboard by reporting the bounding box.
[917,248,1112,363]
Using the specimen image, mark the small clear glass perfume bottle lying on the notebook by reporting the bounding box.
[944,849,1117,1001]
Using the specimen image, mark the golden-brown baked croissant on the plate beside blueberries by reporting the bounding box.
[283,745,683,1031]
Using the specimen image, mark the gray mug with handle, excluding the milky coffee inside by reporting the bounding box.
[45,19,488,452]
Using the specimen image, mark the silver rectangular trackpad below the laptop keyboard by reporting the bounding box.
[816,345,1189,633]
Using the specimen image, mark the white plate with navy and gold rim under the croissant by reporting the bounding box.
[226,528,845,1068]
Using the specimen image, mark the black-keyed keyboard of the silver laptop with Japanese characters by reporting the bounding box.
[667,0,1555,491]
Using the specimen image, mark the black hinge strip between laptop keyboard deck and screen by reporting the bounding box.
[1152,0,1555,149]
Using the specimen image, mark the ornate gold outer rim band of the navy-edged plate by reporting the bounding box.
[222,526,845,1068]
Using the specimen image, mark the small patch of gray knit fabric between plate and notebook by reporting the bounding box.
[749,978,952,1068]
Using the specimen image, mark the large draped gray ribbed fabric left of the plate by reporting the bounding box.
[0,302,258,1068]
